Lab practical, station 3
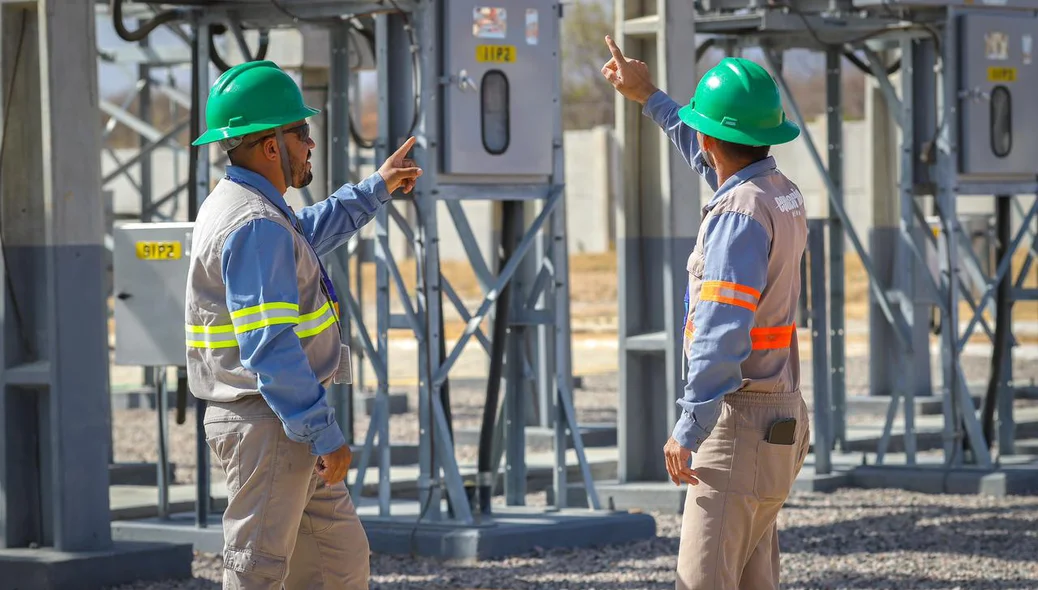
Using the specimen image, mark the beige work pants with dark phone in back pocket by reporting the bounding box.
[675,392,810,590]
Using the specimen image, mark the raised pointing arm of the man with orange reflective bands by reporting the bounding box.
[602,36,717,190]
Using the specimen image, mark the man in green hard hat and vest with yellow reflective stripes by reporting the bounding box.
[185,61,421,590]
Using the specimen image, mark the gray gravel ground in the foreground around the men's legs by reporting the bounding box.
[109,490,1038,590]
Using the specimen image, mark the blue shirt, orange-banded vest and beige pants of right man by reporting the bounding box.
[643,91,809,590]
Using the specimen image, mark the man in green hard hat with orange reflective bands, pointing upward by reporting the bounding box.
[602,37,809,590]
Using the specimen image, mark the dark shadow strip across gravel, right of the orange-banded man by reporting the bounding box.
[780,507,1038,561]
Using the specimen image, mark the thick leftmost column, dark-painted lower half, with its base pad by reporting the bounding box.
[0,0,191,589]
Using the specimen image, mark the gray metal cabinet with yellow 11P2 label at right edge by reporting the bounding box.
[957,11,1038,176]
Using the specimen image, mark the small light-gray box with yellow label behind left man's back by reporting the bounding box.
[112,222,194,367]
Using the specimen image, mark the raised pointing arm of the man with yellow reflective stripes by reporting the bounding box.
[296,137,421,260]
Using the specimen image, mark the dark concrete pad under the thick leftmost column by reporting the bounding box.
[0,539,193,590]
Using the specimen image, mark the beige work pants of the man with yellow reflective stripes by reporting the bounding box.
[204,396,370,590]
